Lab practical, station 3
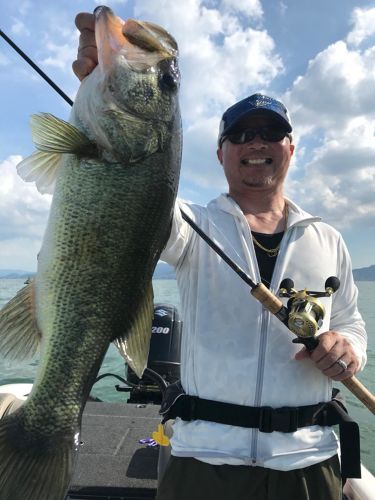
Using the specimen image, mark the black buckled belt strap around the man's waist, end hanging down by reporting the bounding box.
[161,394,361,479]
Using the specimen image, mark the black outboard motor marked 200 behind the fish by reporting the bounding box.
[126,303,182,403]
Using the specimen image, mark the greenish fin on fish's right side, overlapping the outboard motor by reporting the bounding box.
[114,283,154,378]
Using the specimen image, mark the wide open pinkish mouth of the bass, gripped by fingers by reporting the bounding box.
[94,5,178,69]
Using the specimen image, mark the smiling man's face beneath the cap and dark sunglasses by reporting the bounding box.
[217,114,294,195]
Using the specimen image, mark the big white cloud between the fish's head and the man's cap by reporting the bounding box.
[135,0,283,120]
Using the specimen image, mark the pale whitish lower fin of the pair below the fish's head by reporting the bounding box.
[17,151,61,194]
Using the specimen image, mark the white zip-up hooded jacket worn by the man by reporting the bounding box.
[161,195,366,470]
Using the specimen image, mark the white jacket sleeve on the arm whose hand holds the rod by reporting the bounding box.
[330,232,367,370]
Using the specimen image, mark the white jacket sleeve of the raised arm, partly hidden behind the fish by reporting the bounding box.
[160,200,196,267]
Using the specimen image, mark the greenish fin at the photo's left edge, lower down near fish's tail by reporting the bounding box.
[0,280,42,359]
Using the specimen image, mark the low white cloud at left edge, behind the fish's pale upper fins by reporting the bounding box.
[0,155,51,269]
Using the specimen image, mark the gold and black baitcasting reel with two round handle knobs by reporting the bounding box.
[279,276,340,338]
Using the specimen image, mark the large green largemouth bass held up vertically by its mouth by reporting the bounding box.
[0,7,181,500]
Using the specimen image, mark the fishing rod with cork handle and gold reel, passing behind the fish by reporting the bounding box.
[0,30,375,414]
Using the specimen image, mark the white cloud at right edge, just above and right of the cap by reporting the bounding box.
[284,41,375,133]
